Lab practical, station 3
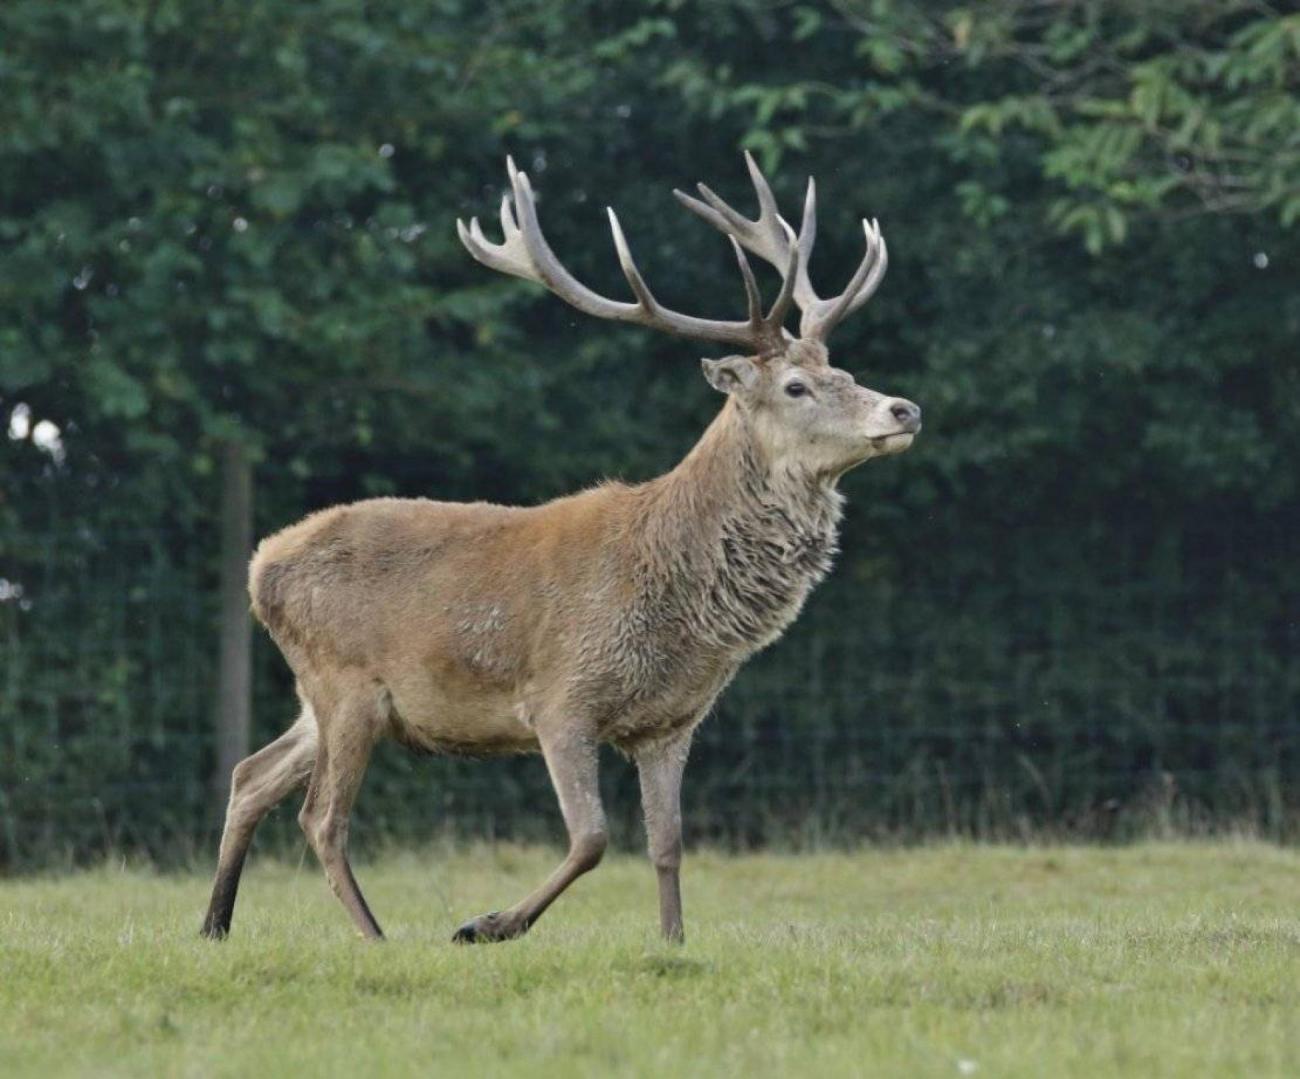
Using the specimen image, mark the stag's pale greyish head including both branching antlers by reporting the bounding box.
[456,152,920,478]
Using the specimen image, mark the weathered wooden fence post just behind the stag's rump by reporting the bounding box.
[212,438,252,814]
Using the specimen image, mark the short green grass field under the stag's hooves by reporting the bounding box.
[0,842,1300,1076]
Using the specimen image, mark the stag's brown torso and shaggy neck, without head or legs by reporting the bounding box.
[250,404,840,755]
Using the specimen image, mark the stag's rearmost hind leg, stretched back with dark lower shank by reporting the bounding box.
[202,706,316,940]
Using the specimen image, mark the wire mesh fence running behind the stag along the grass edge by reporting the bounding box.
[0,501,1300,867]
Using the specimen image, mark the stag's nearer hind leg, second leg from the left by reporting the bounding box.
[298,688,384,940]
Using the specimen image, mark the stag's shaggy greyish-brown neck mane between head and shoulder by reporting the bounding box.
[631,400,842,651]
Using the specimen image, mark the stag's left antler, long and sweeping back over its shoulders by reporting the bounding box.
[456,157,806,352]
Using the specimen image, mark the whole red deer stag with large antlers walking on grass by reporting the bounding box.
[203,156,920,941]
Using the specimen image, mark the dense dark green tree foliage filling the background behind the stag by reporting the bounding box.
[0,0,1300,863]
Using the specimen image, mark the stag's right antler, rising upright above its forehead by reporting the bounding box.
[672,151,889,342]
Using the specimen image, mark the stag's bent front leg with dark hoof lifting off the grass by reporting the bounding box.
[452,731,608,944]
